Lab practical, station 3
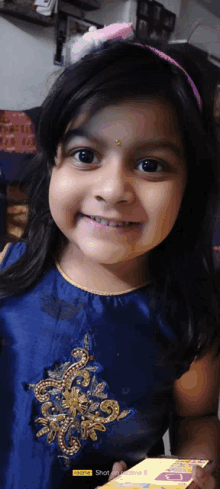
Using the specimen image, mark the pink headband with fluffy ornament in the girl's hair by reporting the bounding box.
[71,22,202,111]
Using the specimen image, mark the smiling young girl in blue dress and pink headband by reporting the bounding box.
[0,24,219,489]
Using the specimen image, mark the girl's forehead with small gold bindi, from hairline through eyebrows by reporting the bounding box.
[61,95,183,157]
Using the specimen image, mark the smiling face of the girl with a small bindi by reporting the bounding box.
[49,97,186,284]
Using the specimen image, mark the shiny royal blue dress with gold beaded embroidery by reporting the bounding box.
[0,242,196,489]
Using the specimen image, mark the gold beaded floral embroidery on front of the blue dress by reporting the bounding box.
[28,334,132,462]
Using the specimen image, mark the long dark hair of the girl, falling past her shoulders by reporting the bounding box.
[0,32,220,368]
